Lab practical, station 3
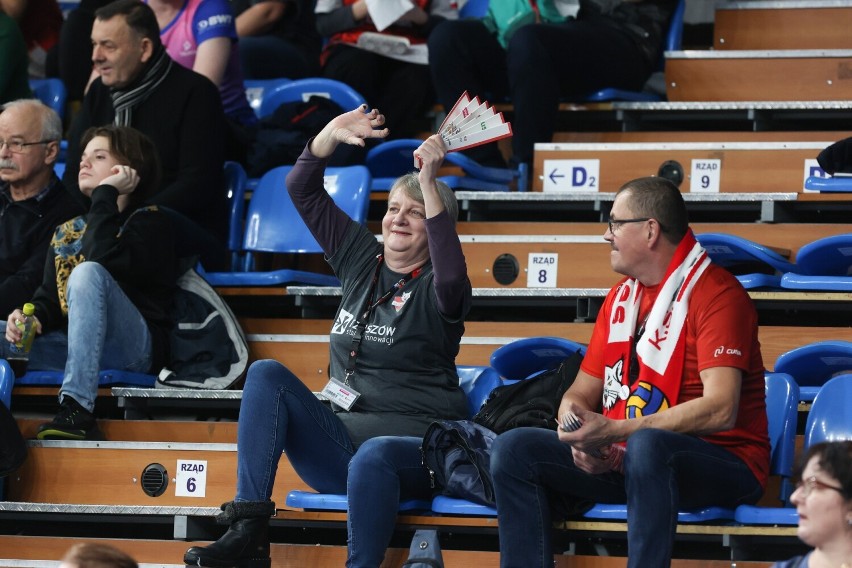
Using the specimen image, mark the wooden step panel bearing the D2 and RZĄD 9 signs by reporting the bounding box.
[533,139,833,194]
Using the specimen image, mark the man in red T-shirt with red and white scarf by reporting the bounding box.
[491,177,769,568]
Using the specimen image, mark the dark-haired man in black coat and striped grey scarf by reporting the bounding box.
[63,0,228,270]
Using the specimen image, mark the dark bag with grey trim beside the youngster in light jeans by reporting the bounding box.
[156,268,248,389]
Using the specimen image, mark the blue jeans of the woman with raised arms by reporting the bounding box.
[235,360,431,567]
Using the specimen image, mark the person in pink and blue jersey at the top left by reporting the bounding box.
[146,0,256,164]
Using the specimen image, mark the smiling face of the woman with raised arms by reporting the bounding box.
[382,187,429,263]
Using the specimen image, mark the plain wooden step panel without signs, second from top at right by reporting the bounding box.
[665,49,852,102]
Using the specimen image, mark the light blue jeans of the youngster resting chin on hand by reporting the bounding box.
[0,262,151,412]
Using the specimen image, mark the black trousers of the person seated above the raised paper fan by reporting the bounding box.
[429,19,653,163]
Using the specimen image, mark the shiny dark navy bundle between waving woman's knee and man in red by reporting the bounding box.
[420,420,497,506]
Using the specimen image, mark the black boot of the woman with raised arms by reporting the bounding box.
[183,501,275,568]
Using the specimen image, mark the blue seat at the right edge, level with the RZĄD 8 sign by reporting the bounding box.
[781,233,852,292]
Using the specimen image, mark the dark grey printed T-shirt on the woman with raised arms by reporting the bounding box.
[328,223,471,445]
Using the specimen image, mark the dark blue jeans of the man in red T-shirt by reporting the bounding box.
[491,428,763,568]
